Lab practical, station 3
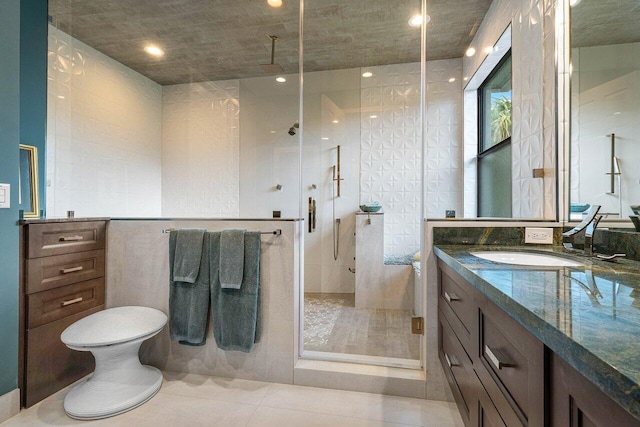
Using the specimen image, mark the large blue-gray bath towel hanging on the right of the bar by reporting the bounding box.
[207,231,260,353]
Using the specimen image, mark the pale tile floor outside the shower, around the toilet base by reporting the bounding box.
[0,373,463,427]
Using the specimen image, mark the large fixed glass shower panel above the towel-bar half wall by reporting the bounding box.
[46,0,300,218]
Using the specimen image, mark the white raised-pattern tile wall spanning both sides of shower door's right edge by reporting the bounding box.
[360,59,463,249]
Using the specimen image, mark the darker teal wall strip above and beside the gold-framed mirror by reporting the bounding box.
[20,0,48,216]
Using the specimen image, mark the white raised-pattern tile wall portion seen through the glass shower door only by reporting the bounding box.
[360,63,422,256]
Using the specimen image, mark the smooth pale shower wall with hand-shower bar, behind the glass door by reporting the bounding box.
[302,68,360,293]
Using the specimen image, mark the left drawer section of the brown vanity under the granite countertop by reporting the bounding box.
[438,261,545,427]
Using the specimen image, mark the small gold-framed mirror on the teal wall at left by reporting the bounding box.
[18,144,40,218]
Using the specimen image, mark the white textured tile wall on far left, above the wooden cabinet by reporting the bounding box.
[46,26,162,217]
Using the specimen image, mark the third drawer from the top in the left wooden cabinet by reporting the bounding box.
[27,277,104,329]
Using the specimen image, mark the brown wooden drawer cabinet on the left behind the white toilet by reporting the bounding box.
[19,220,106,407]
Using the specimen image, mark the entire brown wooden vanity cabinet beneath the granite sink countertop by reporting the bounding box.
[438,260,640,427]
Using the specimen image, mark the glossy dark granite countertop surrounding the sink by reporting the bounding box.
[434,245,640,420]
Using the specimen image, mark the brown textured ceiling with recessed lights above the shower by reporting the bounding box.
[49,0,490,85]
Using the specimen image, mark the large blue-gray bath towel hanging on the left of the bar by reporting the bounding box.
[169,230,211,345]
